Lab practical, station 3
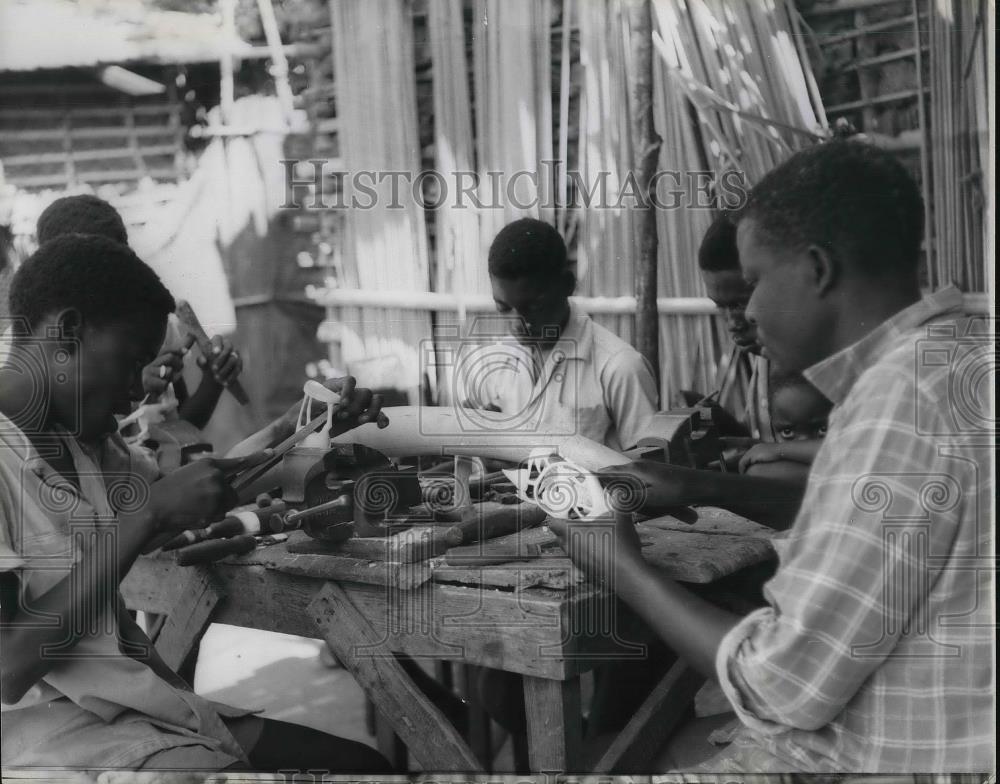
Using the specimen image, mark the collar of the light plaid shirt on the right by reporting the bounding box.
[803,286,963,405]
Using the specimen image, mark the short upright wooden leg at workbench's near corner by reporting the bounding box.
[524,675,583,773]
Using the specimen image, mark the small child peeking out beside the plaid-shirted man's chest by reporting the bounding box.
[740,371,833,479]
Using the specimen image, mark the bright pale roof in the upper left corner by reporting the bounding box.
[0,0,252,71]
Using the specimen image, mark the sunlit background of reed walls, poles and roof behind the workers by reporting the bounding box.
[0,0,994,434]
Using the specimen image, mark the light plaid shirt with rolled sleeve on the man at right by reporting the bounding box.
[716,288,995,773]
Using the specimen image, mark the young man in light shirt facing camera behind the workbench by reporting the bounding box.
[457,218,657,451]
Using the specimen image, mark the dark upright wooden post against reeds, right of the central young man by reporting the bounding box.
[627,0,662,388]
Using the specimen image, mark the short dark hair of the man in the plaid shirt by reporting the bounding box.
[737,139,924,278]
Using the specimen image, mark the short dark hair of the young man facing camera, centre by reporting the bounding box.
[489,218,570,281]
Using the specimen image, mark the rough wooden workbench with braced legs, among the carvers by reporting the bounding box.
[122,508,773,772]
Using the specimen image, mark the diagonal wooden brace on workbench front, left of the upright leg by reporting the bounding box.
[308,583,483,772]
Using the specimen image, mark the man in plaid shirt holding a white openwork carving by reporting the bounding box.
[555,141,995,773]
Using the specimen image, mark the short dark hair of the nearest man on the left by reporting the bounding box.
[10,234,174,329]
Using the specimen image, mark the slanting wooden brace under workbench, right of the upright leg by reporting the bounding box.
[591,661,705,774]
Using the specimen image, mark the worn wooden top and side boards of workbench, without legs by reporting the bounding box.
[122,508,774,679]
